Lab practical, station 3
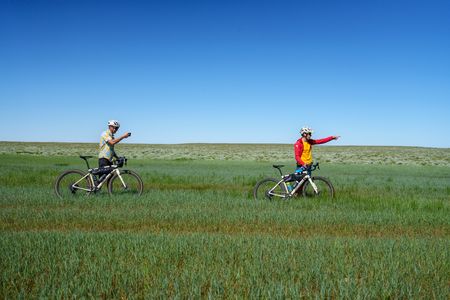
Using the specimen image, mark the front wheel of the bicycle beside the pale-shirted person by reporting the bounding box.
[108,170,144,196]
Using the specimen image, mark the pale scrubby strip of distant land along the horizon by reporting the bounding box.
[0,142,450,166]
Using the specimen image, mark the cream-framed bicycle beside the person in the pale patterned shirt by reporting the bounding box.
[54,155,144,199]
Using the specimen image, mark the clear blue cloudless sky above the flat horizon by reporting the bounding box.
[0,0,450,148]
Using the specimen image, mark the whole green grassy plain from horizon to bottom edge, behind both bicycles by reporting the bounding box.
[0,142,450,299]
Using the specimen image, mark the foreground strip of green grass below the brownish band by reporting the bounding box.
[0,232,449,299]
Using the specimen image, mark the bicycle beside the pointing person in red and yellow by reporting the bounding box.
[253,163,335,200]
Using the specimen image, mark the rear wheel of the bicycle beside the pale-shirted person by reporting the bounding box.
[54,170,92,199]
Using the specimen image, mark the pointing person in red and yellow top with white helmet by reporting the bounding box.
[294,127,340,173]
